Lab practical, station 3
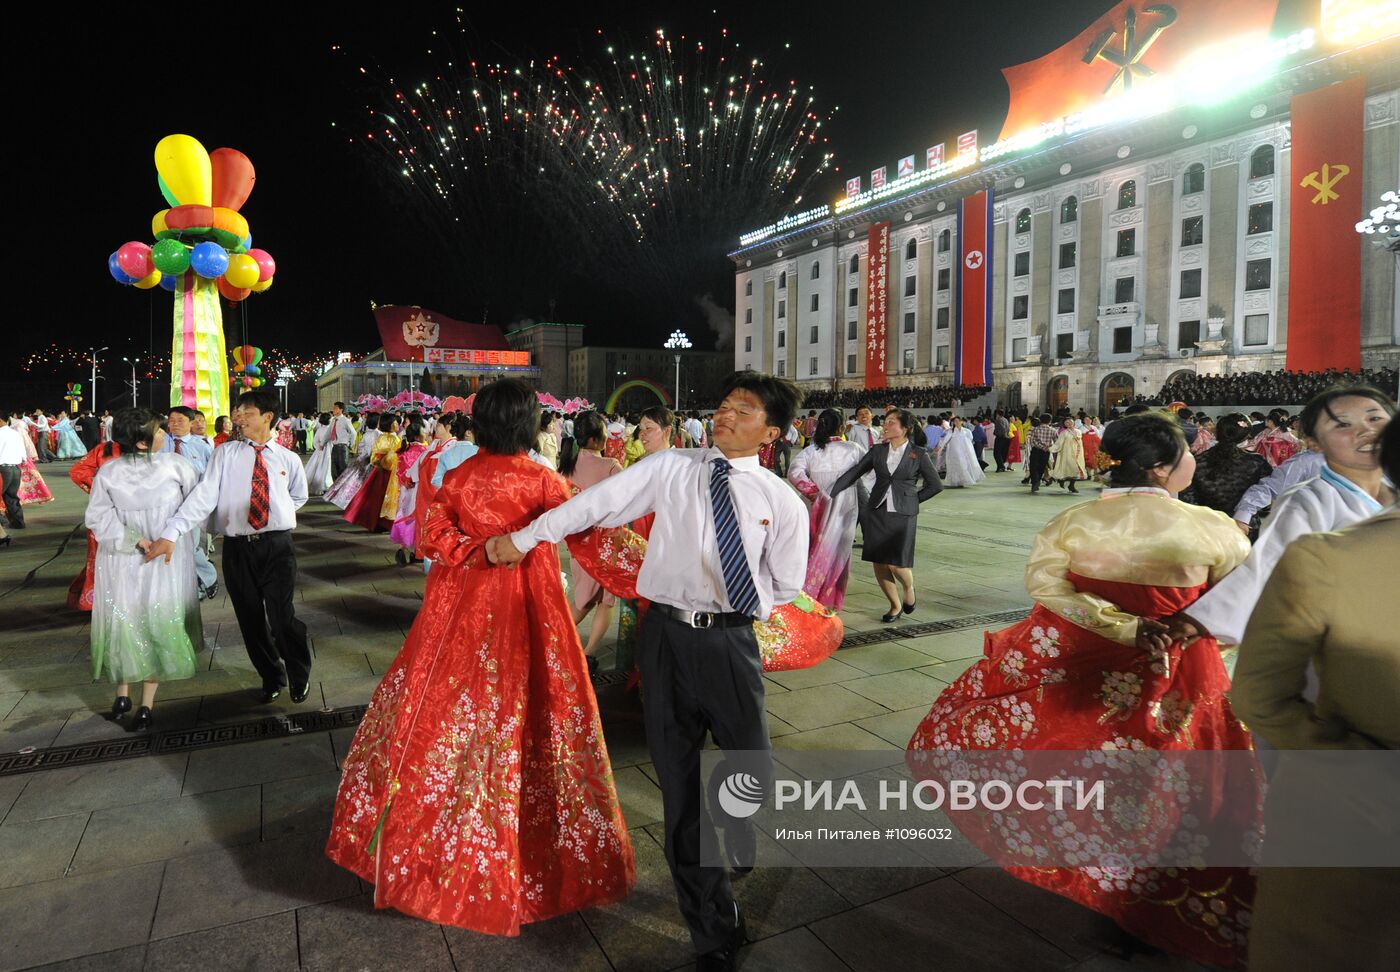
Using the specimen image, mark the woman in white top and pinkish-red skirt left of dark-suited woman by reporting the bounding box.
[788,409,865,611]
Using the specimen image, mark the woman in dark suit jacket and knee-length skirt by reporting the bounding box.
[832,409,944,625]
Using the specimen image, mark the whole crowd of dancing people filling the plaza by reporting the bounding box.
[0,373,1400,968]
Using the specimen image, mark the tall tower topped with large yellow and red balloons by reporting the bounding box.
[108,134,277,420]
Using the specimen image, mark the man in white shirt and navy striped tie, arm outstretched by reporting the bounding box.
[487,371,808,968]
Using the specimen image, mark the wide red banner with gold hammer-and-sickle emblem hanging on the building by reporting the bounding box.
[1274,77,1366,371]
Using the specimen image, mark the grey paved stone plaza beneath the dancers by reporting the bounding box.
[0,464,1200,972]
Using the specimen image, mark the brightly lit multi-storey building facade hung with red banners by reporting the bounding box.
[729,0,1400,410]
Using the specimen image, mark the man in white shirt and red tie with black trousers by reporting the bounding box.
[146,391,311,704]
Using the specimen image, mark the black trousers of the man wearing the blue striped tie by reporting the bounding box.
[637,611,773,954]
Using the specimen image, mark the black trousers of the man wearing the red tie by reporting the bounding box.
[224,531,311,688]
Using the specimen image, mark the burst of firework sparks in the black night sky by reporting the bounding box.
[333,15,834,319]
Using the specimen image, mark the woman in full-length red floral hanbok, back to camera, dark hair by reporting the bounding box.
[326,378,636,936]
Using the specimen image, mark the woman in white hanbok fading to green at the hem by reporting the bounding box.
[85,409,204,730]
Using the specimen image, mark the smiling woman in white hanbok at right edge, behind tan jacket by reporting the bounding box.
[1175,387,1396,669]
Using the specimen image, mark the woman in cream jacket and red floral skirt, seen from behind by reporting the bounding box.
[909,413,1261,968]
